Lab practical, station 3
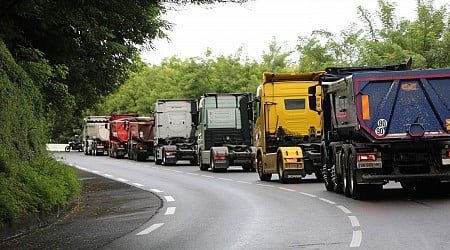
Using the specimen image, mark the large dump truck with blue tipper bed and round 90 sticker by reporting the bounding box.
[310,62,450,199]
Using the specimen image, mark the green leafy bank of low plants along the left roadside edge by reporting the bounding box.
[0,41,81,221]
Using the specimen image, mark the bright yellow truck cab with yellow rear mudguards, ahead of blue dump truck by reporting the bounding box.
[254,72,324,183]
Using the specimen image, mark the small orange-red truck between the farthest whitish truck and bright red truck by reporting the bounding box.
[109,113,139,158]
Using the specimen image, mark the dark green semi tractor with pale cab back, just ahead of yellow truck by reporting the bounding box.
[197,93,255,171]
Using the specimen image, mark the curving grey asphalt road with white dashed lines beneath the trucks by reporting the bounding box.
[56,152,450,249]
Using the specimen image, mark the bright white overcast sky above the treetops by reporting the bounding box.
[142,0,448,64]
